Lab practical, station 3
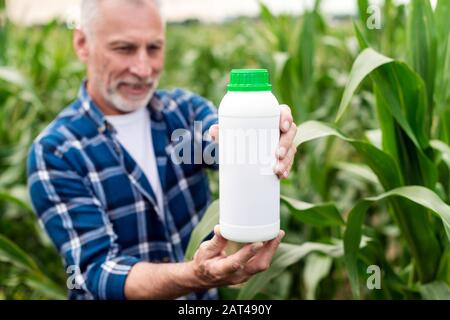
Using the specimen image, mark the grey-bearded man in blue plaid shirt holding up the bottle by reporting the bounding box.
[28,0,296,299]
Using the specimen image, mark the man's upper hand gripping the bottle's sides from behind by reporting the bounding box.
[209,104,297,179]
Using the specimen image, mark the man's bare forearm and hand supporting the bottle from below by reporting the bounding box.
[125,226,284,299]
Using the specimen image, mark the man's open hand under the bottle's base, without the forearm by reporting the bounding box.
[192,225,284,288]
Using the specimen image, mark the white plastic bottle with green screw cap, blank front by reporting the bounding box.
[219,69,280,243]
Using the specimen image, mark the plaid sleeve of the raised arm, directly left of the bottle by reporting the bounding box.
[191,95,219,170]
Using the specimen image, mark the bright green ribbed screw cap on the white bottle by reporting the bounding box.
[227,69,272,91]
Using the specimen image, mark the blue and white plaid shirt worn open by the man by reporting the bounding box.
[27,83,217,299]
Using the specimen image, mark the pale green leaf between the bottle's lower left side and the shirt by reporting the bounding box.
[185,200,219,260]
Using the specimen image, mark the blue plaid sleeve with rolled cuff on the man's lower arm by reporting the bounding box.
[27,142,139,300]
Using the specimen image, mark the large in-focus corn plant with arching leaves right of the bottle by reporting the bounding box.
[187,0,450,299]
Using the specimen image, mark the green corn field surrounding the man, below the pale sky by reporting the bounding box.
[0,0,450,299]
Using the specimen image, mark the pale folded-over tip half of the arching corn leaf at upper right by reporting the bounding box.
[335,48,394,122]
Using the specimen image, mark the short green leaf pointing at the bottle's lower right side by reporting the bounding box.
[281,196,345,227]
